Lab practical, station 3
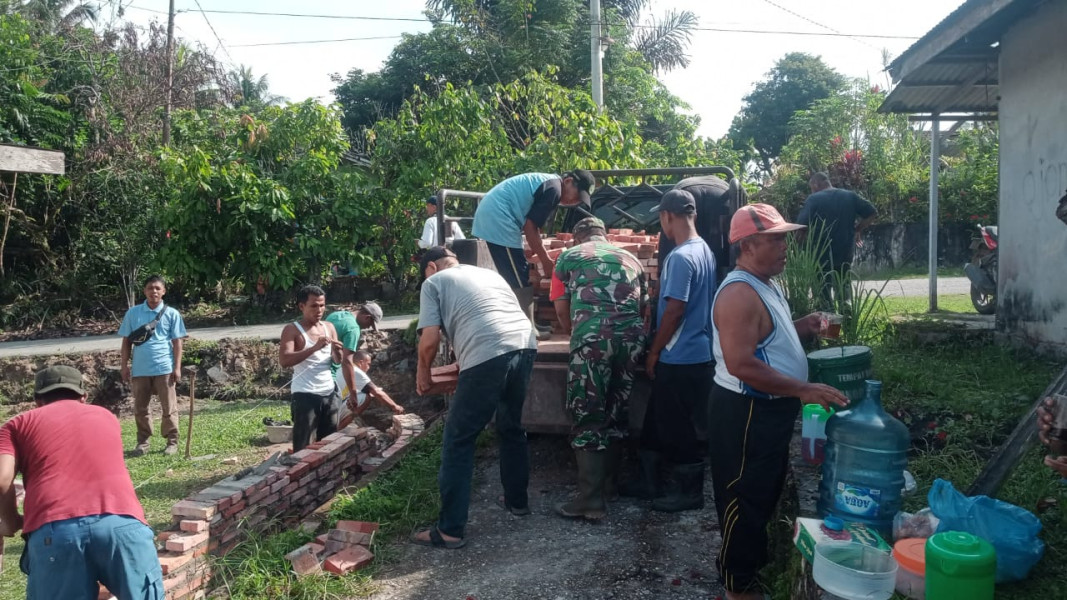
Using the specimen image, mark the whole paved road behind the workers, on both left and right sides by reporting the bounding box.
[0,278,970,358]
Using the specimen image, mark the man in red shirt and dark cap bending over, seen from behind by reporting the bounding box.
[0,366,163,600]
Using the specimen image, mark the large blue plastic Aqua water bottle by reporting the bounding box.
[818,380,910,531]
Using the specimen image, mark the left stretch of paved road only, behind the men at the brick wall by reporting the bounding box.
[0,315,418,358]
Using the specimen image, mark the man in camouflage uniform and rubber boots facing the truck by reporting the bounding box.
[550,217,644,520]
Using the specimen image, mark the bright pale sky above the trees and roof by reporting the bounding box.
[116,0,962,138]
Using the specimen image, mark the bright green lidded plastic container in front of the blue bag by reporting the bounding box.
[926,532,997,600]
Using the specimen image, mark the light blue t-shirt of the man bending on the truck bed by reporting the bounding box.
[472,173,560,250]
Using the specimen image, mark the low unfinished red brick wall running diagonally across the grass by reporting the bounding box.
[158,414,424,600]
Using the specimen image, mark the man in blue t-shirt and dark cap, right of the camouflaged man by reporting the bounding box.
[644,189,716,512]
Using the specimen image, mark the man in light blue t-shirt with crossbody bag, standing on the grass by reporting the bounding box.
[118,275,187,456]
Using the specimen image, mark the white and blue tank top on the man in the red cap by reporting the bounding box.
[712,269,808,398]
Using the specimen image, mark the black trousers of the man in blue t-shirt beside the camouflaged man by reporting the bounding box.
[641,362,714,464]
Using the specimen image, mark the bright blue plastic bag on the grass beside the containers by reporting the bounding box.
[928,479,1045,583]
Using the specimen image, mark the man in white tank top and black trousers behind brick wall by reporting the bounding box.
[278,285,341,452]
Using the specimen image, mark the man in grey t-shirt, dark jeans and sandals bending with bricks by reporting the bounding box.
[413,247,537,549]
